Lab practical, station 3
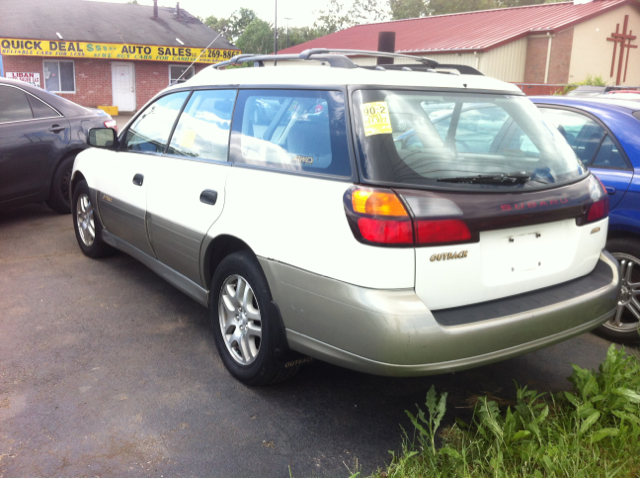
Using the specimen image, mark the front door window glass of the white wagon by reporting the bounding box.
[124,91,189,153]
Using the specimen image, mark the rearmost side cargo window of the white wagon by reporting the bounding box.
[232,90,351,176]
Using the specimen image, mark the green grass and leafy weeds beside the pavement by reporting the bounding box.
[377,346,640,477]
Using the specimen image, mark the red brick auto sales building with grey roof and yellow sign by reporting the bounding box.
[0,0,240,111]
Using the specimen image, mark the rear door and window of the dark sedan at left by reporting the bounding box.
[0,85,70,203]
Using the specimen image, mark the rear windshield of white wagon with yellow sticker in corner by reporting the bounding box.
[354,90,587,189]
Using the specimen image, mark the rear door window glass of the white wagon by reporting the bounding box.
[168,90,236,161]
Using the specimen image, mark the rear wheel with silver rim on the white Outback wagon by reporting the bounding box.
[210,251,299,386]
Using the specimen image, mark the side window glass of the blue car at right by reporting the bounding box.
[540,108,627,168]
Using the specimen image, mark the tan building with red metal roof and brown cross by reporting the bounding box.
[278,0,640,91]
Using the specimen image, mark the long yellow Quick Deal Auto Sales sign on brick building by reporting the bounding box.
[0,38,240,63]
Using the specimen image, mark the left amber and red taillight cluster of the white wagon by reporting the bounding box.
[344,186,472,247]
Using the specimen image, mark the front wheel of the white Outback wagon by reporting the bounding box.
[71,180,113,258]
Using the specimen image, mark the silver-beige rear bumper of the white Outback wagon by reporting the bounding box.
[259,251,620,376]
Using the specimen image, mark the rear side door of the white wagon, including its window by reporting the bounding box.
[147,90,236,284]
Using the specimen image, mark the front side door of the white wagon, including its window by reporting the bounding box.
[98,91,189,256]
